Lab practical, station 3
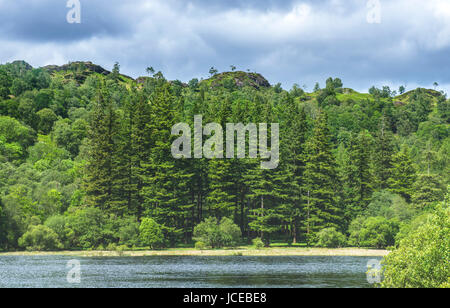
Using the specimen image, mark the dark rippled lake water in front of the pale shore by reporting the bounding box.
[0,256,380,288]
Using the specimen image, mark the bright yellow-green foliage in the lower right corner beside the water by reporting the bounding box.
[381,203,450,288]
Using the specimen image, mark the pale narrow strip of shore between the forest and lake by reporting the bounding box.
[0,248,389,257]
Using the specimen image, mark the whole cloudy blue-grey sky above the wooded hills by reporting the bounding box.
[0,0,450,93]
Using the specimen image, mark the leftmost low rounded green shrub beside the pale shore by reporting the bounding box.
[19,225,63,251]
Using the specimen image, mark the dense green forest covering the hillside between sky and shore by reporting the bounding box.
[0,61,450,251]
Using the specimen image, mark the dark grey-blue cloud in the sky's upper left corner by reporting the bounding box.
[0,0,132,43]
